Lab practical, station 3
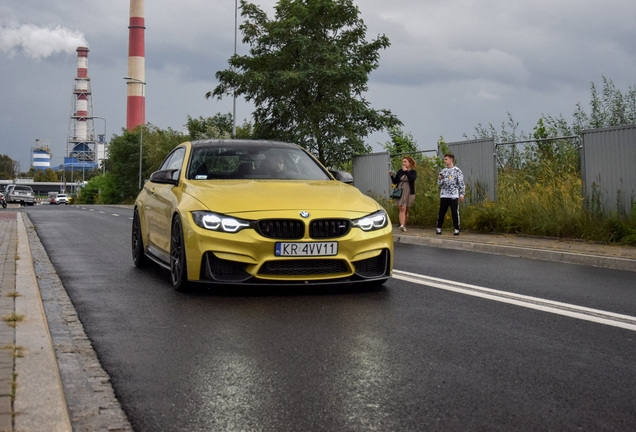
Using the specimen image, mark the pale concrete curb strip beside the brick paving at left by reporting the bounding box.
[14,214,72,432]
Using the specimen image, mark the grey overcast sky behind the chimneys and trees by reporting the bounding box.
[0,0,636,171]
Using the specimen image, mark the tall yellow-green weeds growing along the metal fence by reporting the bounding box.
[383,158,636,245]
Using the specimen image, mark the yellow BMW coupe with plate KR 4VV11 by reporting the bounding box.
[132,140,393,289]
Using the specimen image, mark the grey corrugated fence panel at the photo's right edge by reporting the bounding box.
[581,125,636,215]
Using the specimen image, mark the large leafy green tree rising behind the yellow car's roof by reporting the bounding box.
[206,0,402,167]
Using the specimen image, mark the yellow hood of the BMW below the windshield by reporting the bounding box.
[184,180,381,215]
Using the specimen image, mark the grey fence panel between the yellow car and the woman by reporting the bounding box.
[353,152,391,200]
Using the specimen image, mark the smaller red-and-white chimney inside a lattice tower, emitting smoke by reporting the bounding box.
[64,47,97,174]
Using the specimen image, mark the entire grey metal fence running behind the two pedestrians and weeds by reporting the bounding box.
[353,125,636,215]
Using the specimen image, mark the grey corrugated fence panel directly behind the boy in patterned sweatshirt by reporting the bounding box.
[439,138,497,204]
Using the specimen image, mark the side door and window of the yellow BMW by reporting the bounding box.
[145,147,185,254]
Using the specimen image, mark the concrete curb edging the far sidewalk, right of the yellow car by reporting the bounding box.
[393,234,636,272]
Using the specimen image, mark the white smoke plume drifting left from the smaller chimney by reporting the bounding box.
[0,24,88,59]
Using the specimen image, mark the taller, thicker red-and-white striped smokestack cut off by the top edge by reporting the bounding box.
[126,0,146,130]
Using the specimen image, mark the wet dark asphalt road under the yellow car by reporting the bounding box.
[28,206,636,431]
